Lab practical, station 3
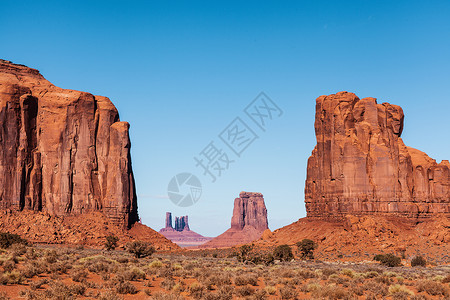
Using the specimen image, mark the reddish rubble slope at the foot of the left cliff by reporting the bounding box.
[0,210,180,250]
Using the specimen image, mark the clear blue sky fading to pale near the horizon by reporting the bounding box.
[0,0,450,236]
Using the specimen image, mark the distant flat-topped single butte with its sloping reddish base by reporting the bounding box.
[200,192,269,248]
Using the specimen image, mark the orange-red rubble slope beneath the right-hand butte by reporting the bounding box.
[254,215,450,264]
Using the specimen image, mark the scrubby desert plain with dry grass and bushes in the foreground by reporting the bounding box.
[0,237,450,300]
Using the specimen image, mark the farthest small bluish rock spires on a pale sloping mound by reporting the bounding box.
[159,212,211,247]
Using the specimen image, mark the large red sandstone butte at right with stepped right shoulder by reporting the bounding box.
[305,92,450,217]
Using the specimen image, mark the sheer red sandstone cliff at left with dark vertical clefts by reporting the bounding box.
[0,60,138,227]
